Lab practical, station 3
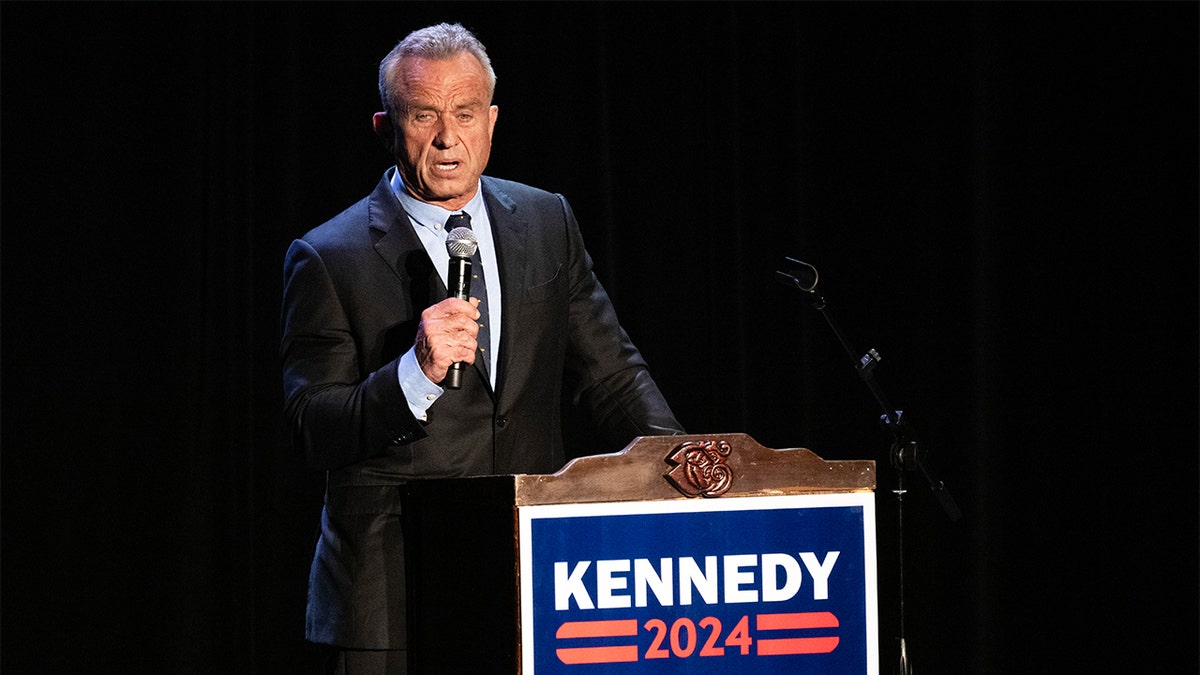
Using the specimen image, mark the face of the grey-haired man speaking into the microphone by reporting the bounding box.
[377,54,498,210]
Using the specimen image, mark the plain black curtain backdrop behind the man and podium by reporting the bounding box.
[0,1,1200,674]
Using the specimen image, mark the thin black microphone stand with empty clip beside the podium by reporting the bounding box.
[775,258,962,675]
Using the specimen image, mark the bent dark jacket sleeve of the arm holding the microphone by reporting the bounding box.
[281,240,425,470]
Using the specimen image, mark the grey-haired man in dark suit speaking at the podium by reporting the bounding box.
[274,24,683,673]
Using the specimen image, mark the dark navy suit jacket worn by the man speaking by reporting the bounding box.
[281,169,683,649]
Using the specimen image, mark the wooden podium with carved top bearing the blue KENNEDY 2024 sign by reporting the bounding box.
[404,434,878,675]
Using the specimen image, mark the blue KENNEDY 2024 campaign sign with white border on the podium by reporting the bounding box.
[518,492,878,675]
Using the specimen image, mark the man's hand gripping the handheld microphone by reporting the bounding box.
[414,298,479,382]
